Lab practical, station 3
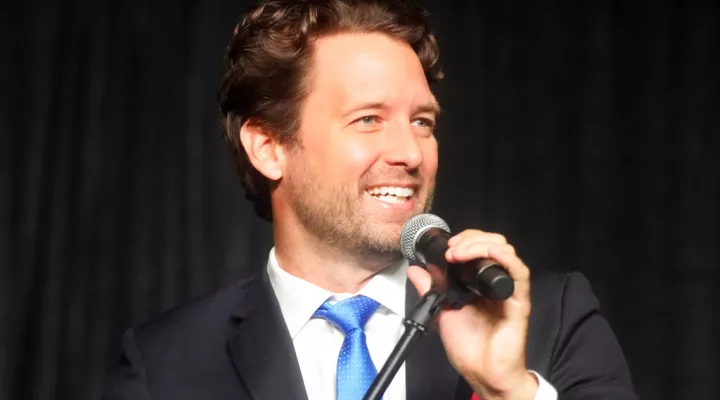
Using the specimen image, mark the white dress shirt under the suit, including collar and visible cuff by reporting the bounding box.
[267,248,557,400]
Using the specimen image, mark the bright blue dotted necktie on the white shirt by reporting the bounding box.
[313,295,380,400]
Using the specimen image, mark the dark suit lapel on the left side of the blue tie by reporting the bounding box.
[228,272,307,400]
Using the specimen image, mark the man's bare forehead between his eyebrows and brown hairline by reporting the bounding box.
[309,33,434,107]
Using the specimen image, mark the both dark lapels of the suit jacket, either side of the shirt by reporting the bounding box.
[227,269,462,400]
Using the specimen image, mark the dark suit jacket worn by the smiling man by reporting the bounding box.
[105,272,635,400]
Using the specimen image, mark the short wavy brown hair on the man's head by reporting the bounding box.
[218,0,442,221]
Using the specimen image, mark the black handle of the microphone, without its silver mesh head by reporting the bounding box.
[415,228,515,300]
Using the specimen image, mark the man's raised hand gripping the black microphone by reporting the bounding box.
[407,230,538,400]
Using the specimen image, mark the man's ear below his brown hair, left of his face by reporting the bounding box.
[240,120,285,181]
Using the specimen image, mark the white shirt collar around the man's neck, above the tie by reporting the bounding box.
[267,247,408,339]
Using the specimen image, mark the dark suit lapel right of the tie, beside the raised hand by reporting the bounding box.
[405,280,470,400]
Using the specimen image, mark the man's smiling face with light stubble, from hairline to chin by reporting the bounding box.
[281,34,438,255]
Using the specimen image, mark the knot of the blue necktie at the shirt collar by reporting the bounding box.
[313,295,380,336]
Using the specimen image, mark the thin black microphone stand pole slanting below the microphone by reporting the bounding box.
[363,289,445,400]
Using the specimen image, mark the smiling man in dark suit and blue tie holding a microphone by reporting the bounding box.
[102,0,635,400]
